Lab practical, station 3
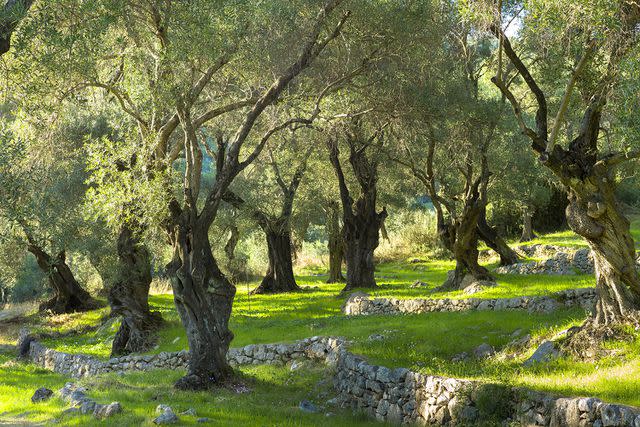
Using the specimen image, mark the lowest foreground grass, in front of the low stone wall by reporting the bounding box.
[0,355,380,427]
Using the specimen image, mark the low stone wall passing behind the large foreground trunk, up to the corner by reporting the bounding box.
[25,337,337,378]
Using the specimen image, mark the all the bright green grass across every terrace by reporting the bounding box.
[0,221,640,425]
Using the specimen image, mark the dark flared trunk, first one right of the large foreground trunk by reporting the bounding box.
[251,221,300,294]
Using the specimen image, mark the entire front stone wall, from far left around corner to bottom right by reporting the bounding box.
[22,337,640,427]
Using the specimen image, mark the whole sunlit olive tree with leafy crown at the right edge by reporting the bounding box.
[484,0,640,333]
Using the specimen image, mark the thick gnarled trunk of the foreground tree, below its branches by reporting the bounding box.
[167,204,236,390]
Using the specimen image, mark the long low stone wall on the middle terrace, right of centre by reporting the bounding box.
[343,288,596,316]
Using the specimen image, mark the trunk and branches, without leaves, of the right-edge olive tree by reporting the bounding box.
[492,15,640,329]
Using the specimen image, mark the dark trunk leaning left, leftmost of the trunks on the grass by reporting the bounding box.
[27,243,99,314]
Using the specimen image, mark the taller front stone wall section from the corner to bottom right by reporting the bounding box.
[335,352,640,427]
